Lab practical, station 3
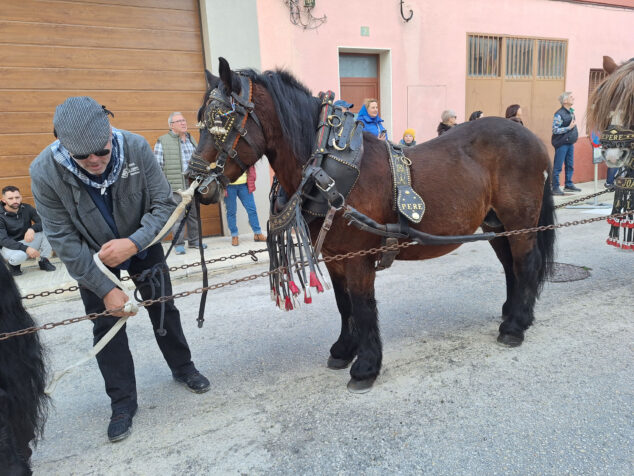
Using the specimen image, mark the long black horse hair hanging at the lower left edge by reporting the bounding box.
[0,263,48,444]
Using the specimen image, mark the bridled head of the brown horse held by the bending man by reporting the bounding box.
[188,58,264,205]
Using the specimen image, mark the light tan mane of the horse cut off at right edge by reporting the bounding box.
[587,58,634,131]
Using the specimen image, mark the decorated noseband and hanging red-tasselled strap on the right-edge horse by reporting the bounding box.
[601,125,634,251]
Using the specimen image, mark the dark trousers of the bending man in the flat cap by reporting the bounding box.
[80,244,196,415]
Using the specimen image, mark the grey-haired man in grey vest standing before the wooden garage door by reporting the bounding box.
[154,112,207,255]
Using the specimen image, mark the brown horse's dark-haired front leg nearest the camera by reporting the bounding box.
[344,256,383,393]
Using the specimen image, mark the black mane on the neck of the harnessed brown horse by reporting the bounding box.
[239,69,320,163]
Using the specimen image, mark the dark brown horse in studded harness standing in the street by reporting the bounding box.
[192,58,554,392]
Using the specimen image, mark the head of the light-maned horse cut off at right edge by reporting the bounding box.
[588,56,634,167]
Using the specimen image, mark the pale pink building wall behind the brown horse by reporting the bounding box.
[258,0,634,147]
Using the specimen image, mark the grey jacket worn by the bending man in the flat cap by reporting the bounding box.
[30,131,176,297]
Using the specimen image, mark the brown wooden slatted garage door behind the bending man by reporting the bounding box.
[0,0,222,235]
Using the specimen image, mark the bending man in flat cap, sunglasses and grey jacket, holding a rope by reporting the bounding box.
[30,96,209,442]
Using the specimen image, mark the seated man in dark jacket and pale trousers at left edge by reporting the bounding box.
[0,185,55,276]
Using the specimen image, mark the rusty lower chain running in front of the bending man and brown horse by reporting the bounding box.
[0,210,632,341]
